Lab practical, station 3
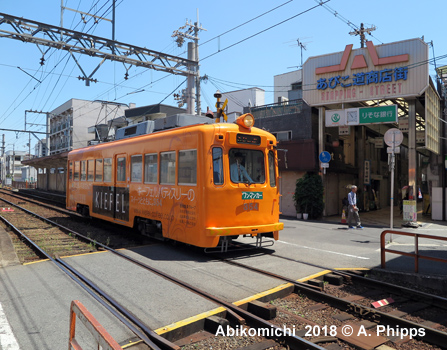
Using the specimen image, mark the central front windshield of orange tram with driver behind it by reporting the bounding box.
[229,148,265,183]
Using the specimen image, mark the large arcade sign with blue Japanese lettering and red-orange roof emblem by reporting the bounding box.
[303,39,429,106]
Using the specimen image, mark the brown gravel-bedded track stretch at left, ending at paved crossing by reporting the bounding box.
[0,191,154,263]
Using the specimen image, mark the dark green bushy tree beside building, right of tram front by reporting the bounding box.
[293,173,324,219]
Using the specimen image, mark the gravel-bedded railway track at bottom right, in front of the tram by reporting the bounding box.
[206,250,447,349]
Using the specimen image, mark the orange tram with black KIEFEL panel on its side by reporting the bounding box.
[67,114,284,251]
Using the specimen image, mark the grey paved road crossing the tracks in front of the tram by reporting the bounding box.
[0,209,447,350]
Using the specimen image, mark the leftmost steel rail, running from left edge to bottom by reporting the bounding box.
[0,215,170,350]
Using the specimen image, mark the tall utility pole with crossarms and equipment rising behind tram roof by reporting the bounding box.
[172,10,206,115]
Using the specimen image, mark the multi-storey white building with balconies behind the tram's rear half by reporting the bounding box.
[48,99,128,155]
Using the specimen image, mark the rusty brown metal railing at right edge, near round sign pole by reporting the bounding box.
[380,230,447,273]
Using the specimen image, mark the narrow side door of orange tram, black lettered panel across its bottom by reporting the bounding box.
[113,154,129,221]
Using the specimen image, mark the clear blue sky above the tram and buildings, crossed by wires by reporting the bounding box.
[0,0,447,151]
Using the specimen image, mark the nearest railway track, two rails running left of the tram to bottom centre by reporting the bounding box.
[1,193,323,350]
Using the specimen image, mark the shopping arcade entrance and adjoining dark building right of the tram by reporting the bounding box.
[250,39,446,220]
